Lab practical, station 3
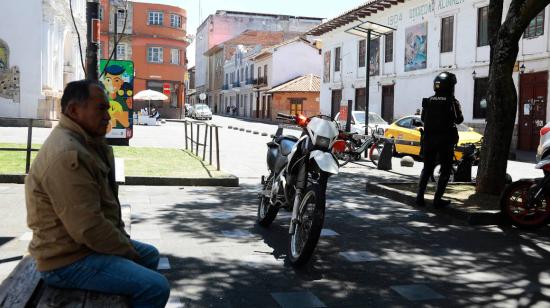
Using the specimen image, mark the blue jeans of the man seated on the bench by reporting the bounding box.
[41,240,170,307]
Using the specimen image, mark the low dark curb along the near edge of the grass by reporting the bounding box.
[0,174,239,187]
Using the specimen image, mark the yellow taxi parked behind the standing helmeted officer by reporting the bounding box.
[384,115,483,160]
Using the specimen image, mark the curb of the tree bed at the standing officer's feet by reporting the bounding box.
[366,183,501,225]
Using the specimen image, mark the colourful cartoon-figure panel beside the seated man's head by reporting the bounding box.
[99,60,134,139]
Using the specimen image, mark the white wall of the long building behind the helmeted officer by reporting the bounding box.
[321,0,550,123]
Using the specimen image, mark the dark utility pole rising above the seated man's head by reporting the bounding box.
[86,0,100,81]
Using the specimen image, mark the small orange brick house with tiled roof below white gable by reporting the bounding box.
[267,74,321,120]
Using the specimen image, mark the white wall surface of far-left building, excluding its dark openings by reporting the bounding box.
[0,0,86,118]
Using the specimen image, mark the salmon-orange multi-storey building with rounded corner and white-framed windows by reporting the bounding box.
[100,0,189,118]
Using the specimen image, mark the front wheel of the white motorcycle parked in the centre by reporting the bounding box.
[288,175,327,267]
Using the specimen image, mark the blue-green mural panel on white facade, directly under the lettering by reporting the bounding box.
[405,22,428,72]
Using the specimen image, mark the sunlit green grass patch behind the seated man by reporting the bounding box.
[0,143,224,178]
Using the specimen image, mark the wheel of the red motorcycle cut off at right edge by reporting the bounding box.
[500,180,550,229]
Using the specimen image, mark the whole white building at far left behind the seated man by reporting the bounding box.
[0,0,86,119]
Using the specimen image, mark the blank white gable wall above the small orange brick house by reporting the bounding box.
[268,41,323,87]
